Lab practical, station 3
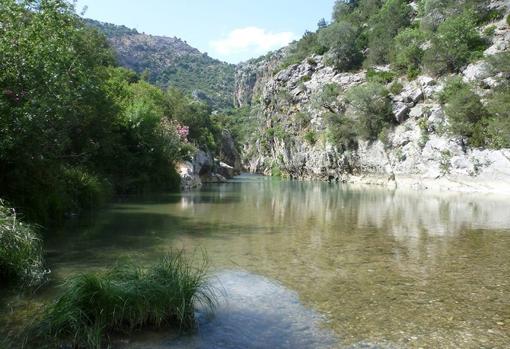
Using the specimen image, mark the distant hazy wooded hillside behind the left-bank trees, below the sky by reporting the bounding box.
[86,19,235,110]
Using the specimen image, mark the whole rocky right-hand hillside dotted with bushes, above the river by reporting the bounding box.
[235,0,510,192]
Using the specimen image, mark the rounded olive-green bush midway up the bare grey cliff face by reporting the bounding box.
[347,82,394,141]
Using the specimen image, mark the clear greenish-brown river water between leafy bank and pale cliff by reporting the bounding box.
[0,176,510,348]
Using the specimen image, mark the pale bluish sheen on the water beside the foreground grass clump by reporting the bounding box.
[123,271,334,349]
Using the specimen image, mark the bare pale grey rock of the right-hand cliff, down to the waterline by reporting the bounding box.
[236,12,510,194]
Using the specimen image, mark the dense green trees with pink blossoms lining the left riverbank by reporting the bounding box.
[0,0,219,223]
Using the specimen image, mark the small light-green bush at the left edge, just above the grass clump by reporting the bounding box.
[0,200,47,289]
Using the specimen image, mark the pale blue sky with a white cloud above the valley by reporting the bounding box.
[77,0,334,63]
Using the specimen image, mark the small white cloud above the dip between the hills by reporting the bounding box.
[209,27,297,56]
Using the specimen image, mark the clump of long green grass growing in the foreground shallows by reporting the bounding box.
[29,252,215,348]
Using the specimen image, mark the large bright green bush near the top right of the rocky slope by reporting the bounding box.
[424,12,486,75]
